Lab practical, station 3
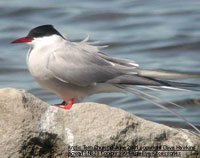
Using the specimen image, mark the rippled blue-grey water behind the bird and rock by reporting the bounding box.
[0,0,200,128]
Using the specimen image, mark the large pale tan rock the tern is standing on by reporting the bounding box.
[0,88,200,158]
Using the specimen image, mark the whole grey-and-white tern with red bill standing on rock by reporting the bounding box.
[12,24,200,133]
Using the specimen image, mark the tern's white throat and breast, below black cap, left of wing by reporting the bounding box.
[27,35,62,81]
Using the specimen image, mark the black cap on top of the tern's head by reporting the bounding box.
[27,25,63,39]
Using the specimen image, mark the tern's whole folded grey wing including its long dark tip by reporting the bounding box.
[47,40,197,87]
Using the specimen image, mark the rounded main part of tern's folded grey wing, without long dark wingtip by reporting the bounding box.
[47,44,133,86]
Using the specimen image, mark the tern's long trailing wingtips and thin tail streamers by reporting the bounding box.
[111,69,200,134]
